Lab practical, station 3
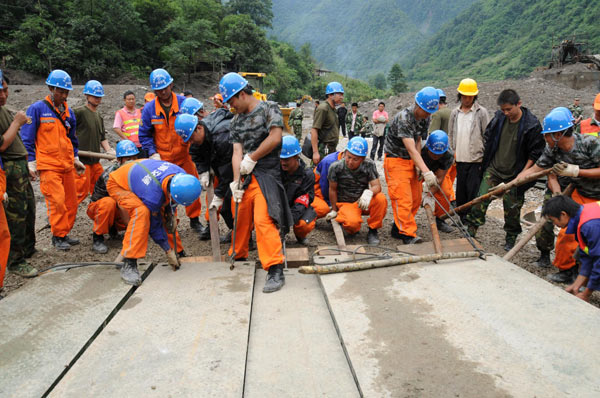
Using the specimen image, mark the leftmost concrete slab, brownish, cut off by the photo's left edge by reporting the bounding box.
[0,264,146,397]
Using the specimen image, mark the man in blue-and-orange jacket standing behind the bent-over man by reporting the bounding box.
[138,69,207,234]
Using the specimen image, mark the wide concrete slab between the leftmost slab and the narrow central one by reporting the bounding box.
[50,263,255,397]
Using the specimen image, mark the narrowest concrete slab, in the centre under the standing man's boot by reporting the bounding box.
[244,269,359,398]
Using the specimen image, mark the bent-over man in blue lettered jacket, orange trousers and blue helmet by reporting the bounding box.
[106,159,202,286]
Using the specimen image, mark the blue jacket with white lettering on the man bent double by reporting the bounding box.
[127,159,185,251]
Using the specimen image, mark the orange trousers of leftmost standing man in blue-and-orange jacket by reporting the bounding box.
[40,169,77,238]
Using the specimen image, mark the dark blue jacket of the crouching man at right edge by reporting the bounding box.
[565,206,600,290]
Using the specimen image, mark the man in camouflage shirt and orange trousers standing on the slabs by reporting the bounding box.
[219,73,293,293]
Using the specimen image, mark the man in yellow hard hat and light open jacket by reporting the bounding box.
[446,78,490,216]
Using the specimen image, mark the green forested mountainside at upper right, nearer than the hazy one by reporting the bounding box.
[404,0,600,86]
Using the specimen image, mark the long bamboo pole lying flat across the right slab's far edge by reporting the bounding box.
[299,252,480,274]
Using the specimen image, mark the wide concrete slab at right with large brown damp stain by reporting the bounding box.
[321,256,600,397]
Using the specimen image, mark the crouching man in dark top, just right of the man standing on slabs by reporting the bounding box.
[279,135,317,246]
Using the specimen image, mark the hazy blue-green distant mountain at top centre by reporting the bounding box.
[272,0,476,78]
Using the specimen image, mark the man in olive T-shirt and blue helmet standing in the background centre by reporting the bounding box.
[310,82,344,165]
